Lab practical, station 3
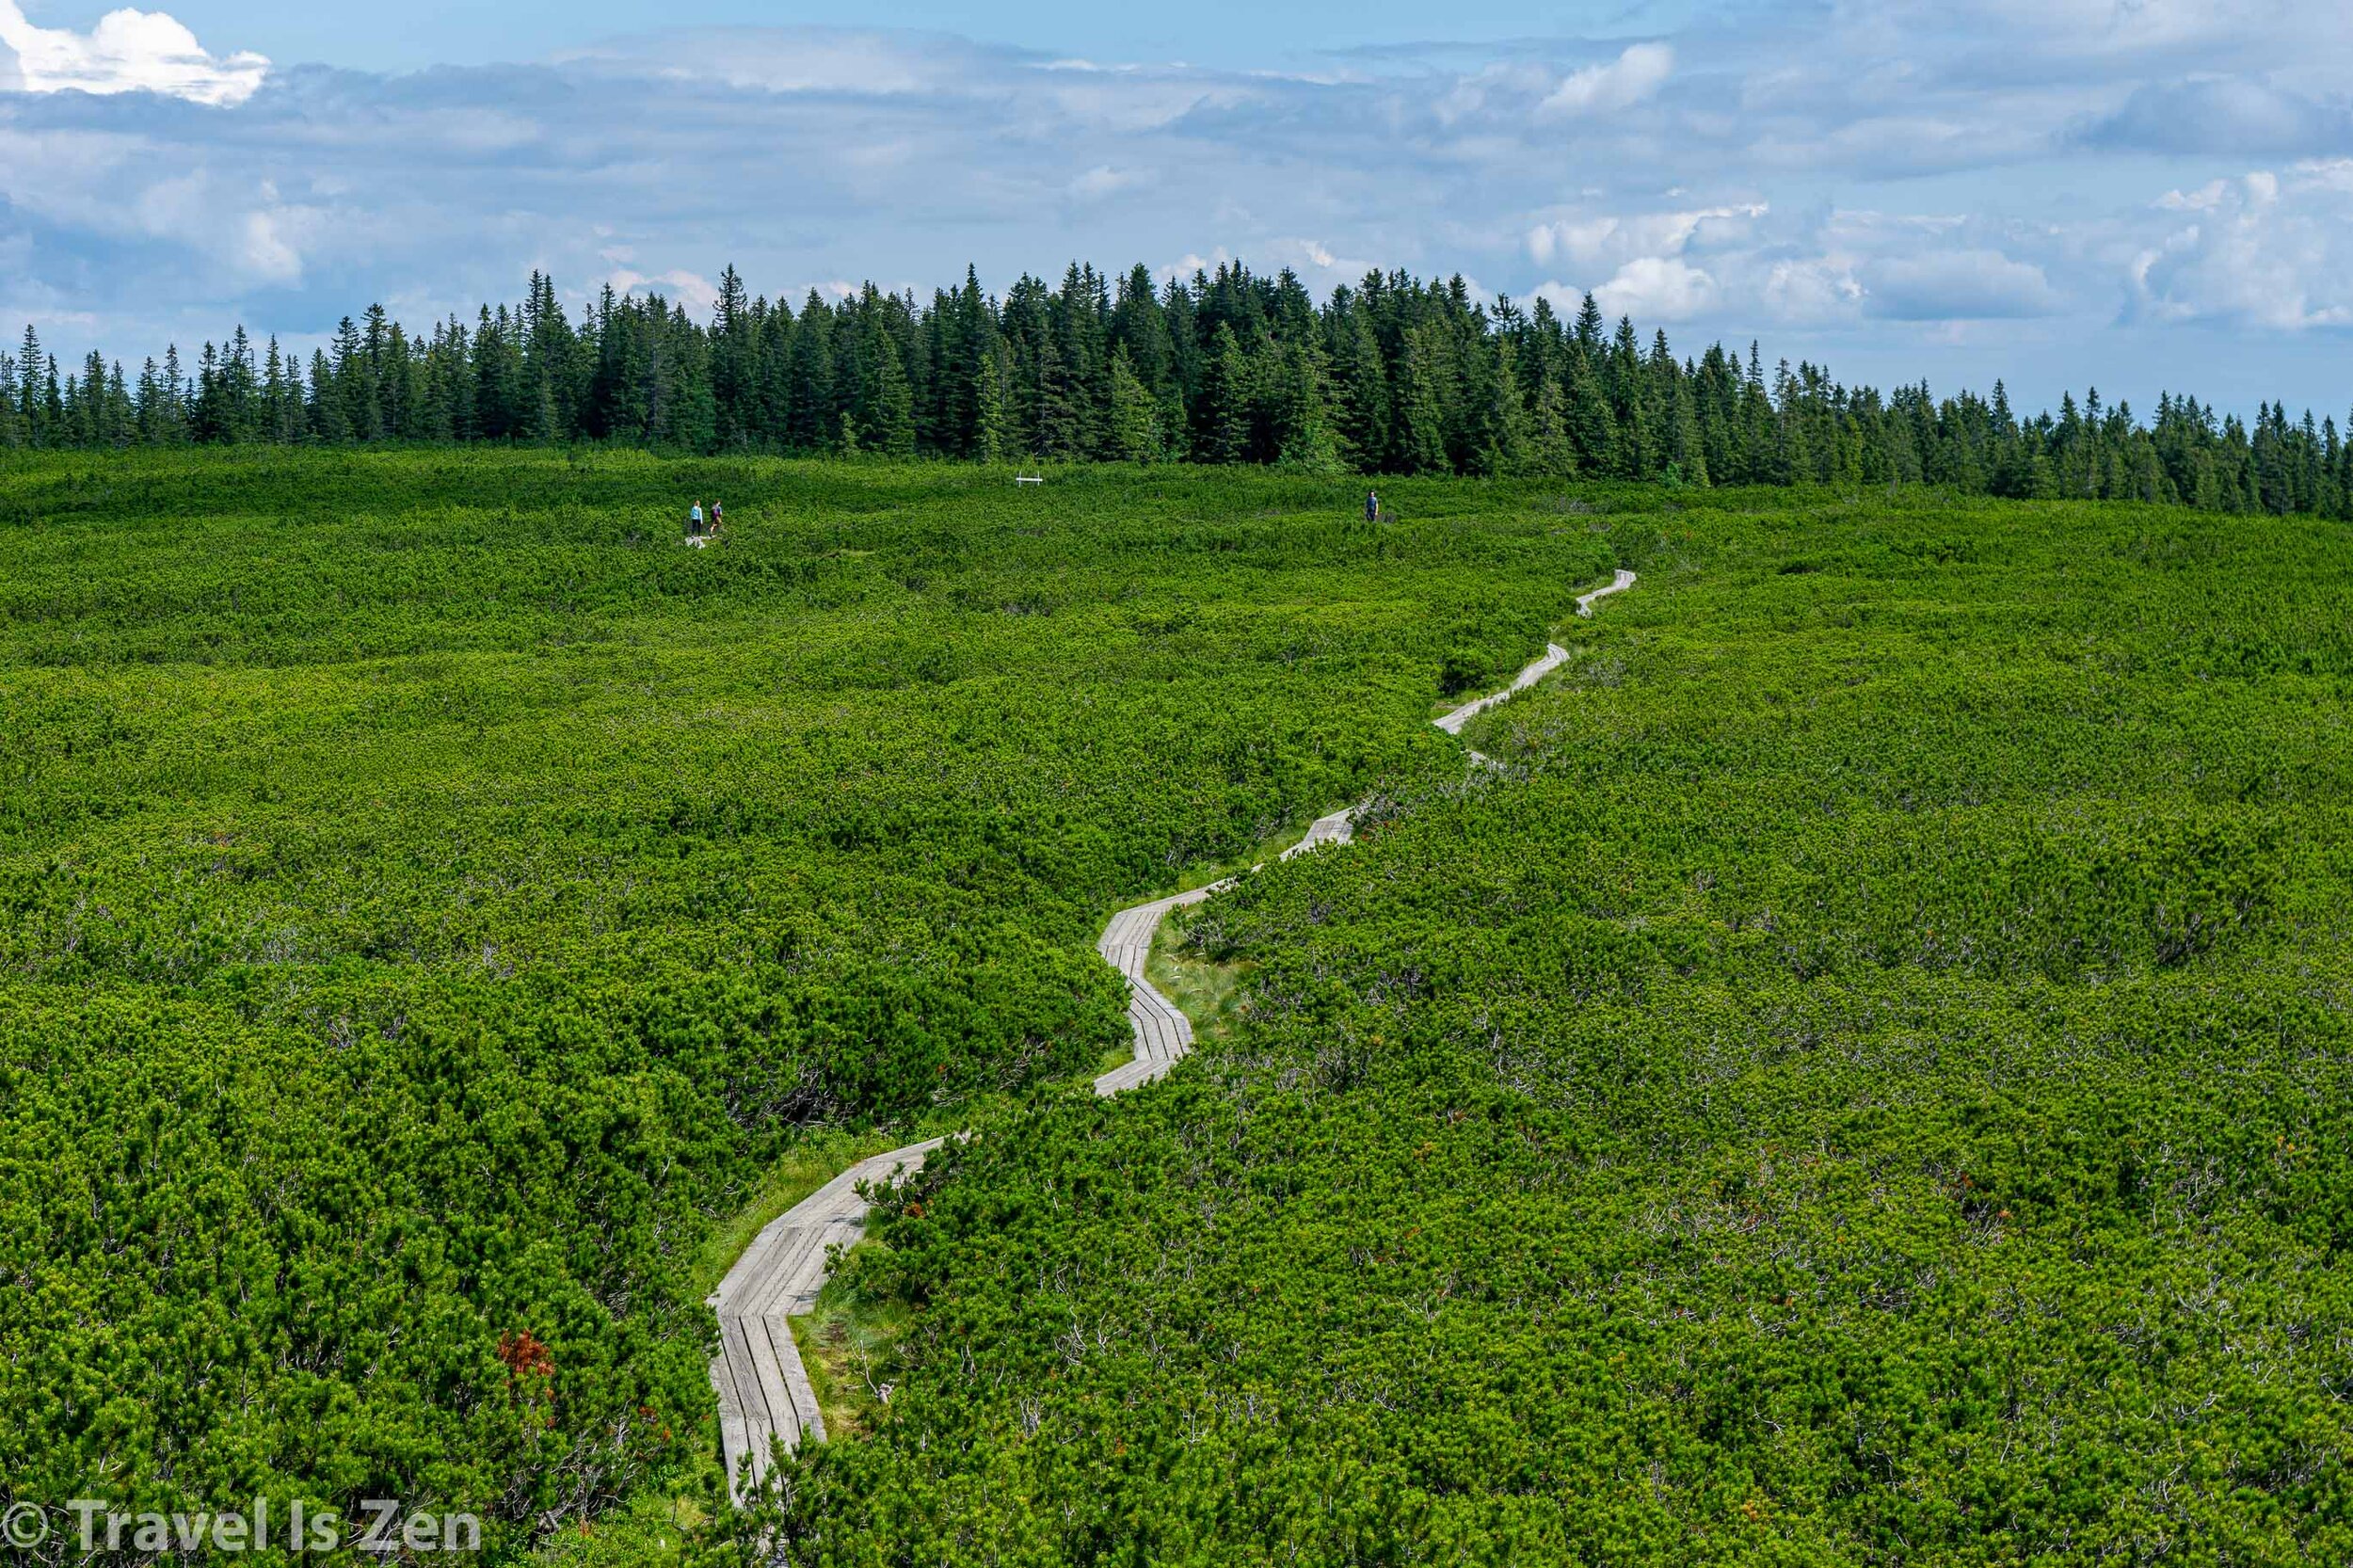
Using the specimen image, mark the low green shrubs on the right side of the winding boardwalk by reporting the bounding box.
[765,492,2353,1565]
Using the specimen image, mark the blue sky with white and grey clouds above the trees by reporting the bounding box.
[0,0,2353,414]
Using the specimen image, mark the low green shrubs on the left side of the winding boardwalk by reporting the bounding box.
[0,450,1609,1560]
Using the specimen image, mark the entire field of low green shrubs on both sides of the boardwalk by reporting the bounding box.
[0,447,2353,1568]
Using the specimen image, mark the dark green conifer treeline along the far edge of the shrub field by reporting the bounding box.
[0,264,2353,516]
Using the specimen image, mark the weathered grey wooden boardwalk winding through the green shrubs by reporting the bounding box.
[711,568,1633,1502]
